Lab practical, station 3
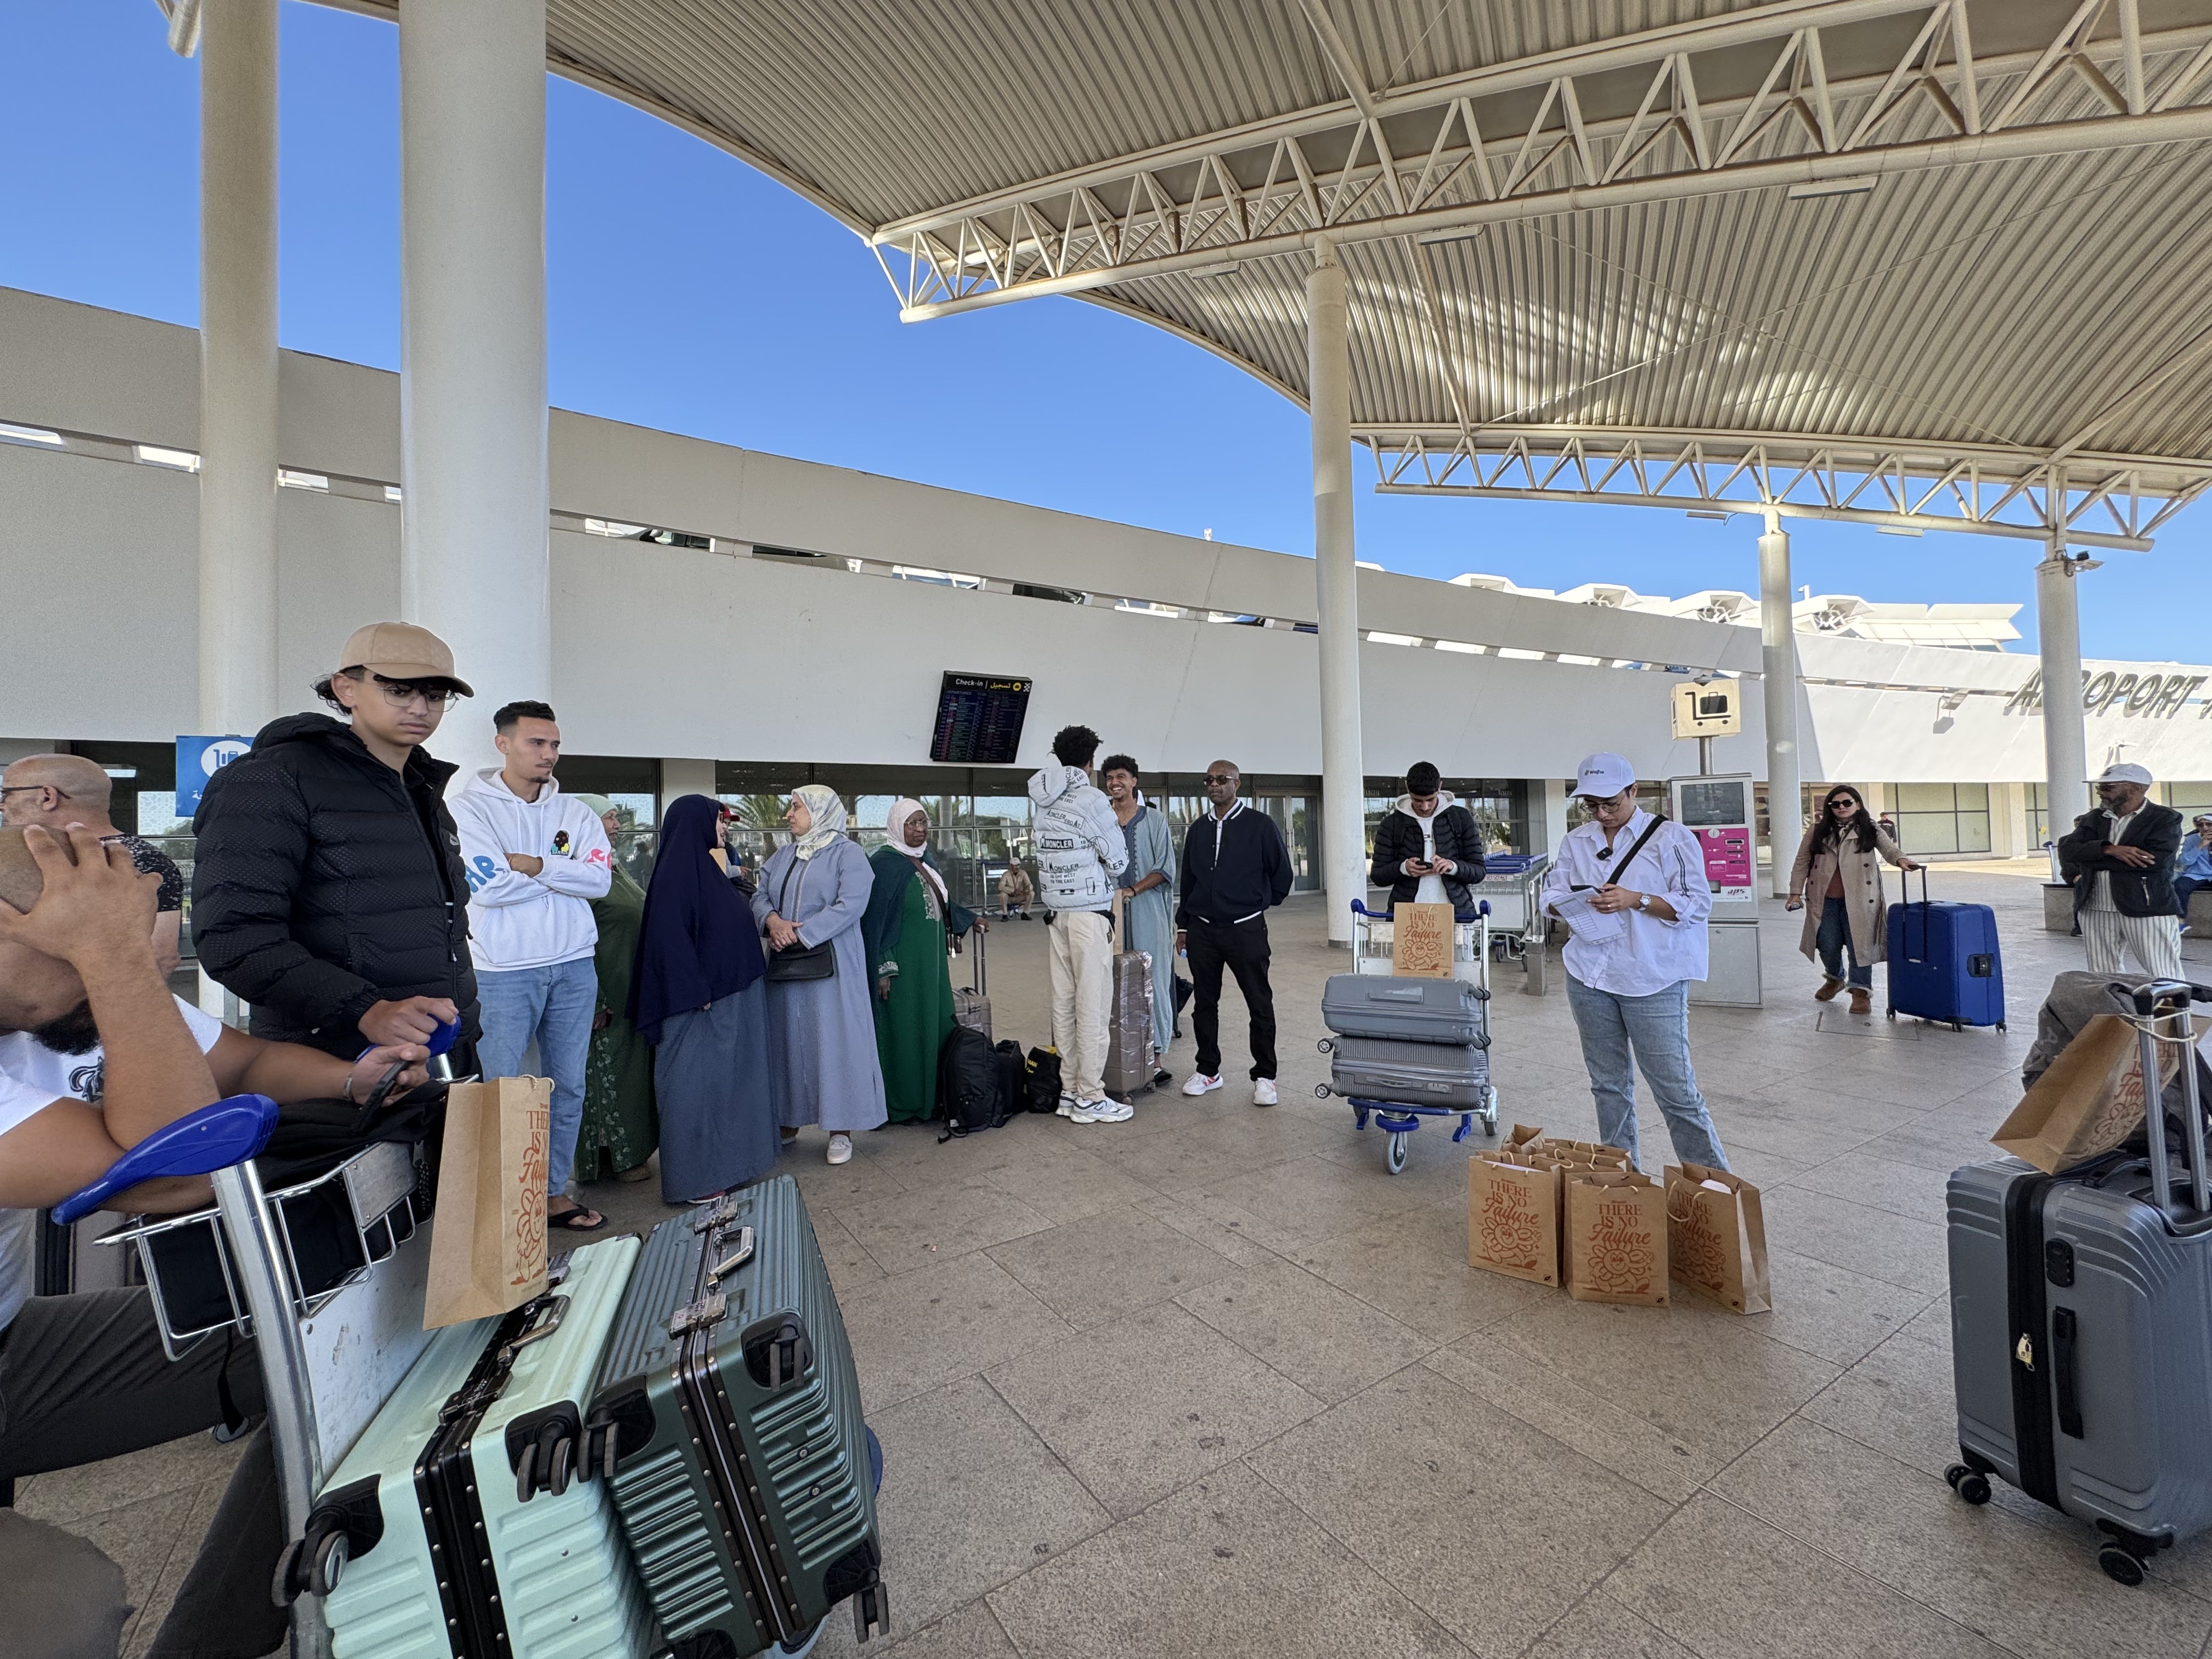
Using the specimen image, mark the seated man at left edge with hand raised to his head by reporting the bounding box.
[0,827,427,1659]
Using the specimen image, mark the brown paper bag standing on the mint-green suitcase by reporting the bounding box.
[422,1077,553,1331]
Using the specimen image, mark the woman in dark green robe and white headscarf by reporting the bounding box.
[860,799,978,1124]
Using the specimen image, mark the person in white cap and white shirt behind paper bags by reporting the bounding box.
[1542,754,1728,1170]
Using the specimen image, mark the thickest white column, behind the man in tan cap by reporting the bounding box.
[400,0,560,781]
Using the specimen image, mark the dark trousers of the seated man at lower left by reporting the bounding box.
[0,1290,285,1659]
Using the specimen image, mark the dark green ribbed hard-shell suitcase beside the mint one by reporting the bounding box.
[586,1175,889,1659]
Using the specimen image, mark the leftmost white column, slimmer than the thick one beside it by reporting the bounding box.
[197,0,281,737]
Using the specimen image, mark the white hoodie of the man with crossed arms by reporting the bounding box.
[454,768,615,973]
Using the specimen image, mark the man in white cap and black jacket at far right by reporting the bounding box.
[2059,761,2181,980]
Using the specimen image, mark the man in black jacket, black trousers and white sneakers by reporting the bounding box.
[1175,761,1290,1106]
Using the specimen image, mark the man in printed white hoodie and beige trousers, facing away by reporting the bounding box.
[1029,725,1132,1124]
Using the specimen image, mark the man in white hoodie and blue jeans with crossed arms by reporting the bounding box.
[454,703,613,1232]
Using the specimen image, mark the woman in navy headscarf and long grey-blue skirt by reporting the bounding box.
[630,794,776,1203]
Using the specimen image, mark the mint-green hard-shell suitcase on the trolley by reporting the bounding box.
[303,1237,654,1659]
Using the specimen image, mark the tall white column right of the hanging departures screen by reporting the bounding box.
[1305,244,1367,945]
